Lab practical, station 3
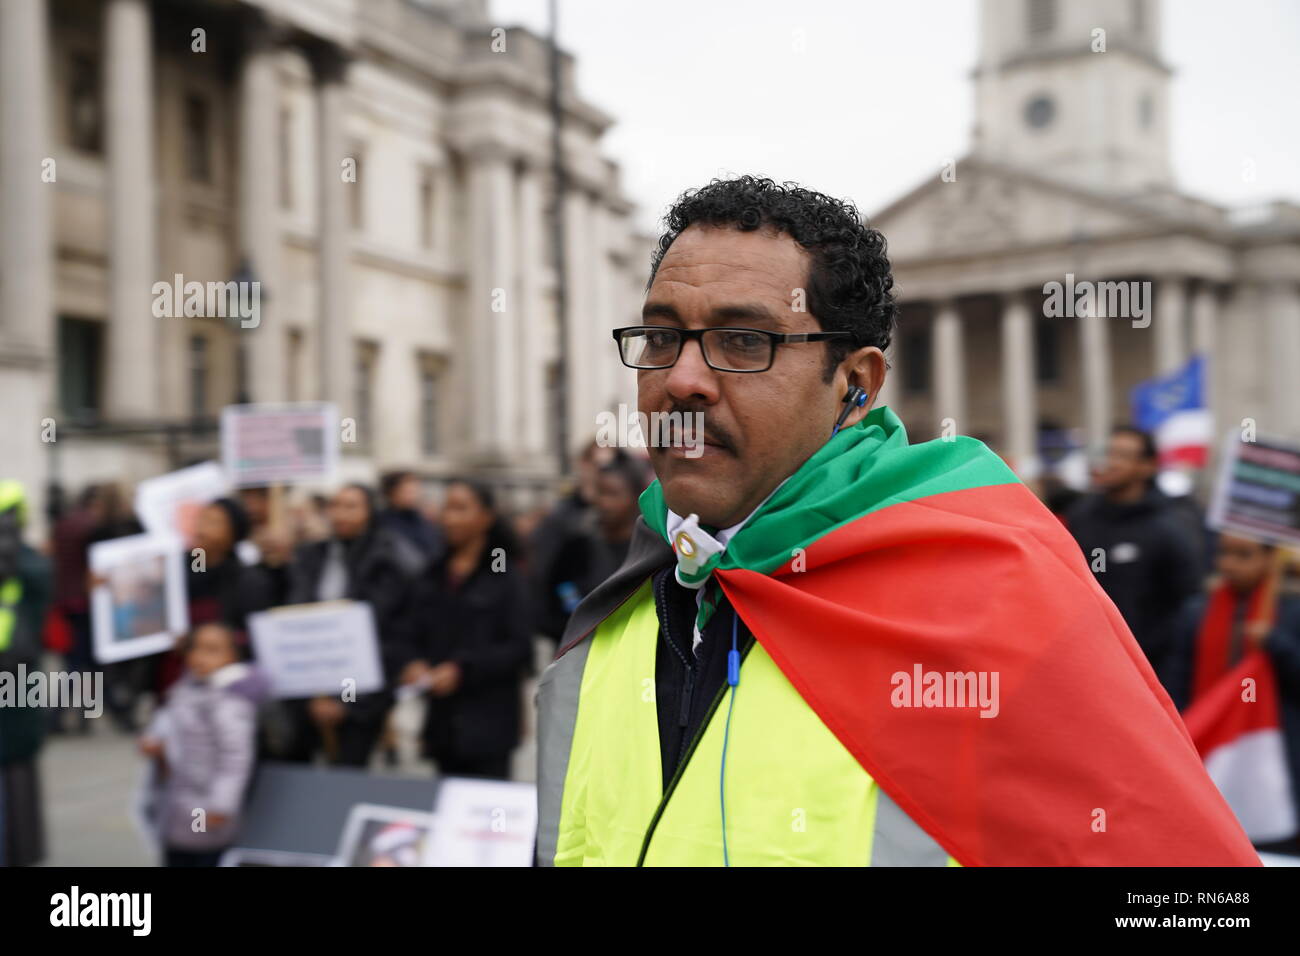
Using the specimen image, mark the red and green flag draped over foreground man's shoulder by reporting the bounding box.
[641,407,1258,865]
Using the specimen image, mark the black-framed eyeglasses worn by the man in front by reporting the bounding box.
[614,325,853,372]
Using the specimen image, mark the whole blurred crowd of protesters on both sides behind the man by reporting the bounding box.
[0,427,1300,865]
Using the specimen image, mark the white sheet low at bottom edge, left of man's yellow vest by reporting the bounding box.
[425,777,537,866]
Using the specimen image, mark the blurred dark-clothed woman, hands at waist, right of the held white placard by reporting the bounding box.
[402,481,533,779]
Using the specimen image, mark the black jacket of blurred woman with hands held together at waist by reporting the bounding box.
[416,553,533,760]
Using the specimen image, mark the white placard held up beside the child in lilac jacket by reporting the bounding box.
[248,601,384,697]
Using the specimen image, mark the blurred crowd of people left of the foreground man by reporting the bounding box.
[0,444,653,865]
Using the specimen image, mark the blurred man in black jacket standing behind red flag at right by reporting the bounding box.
[1066,425,1201,672]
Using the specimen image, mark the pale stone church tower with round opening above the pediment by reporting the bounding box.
[974,0,1173,194]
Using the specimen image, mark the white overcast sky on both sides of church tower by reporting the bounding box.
[490,0,1300,229]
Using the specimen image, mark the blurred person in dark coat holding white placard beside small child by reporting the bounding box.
[285,484,412,766]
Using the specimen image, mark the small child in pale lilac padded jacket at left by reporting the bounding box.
[140,623,267,866]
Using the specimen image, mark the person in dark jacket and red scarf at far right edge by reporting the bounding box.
[1161,532,1300,855]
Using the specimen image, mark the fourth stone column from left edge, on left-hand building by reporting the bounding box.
[312,47,353,421]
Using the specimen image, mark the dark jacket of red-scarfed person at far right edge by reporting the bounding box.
[1161,594,1300,832]
